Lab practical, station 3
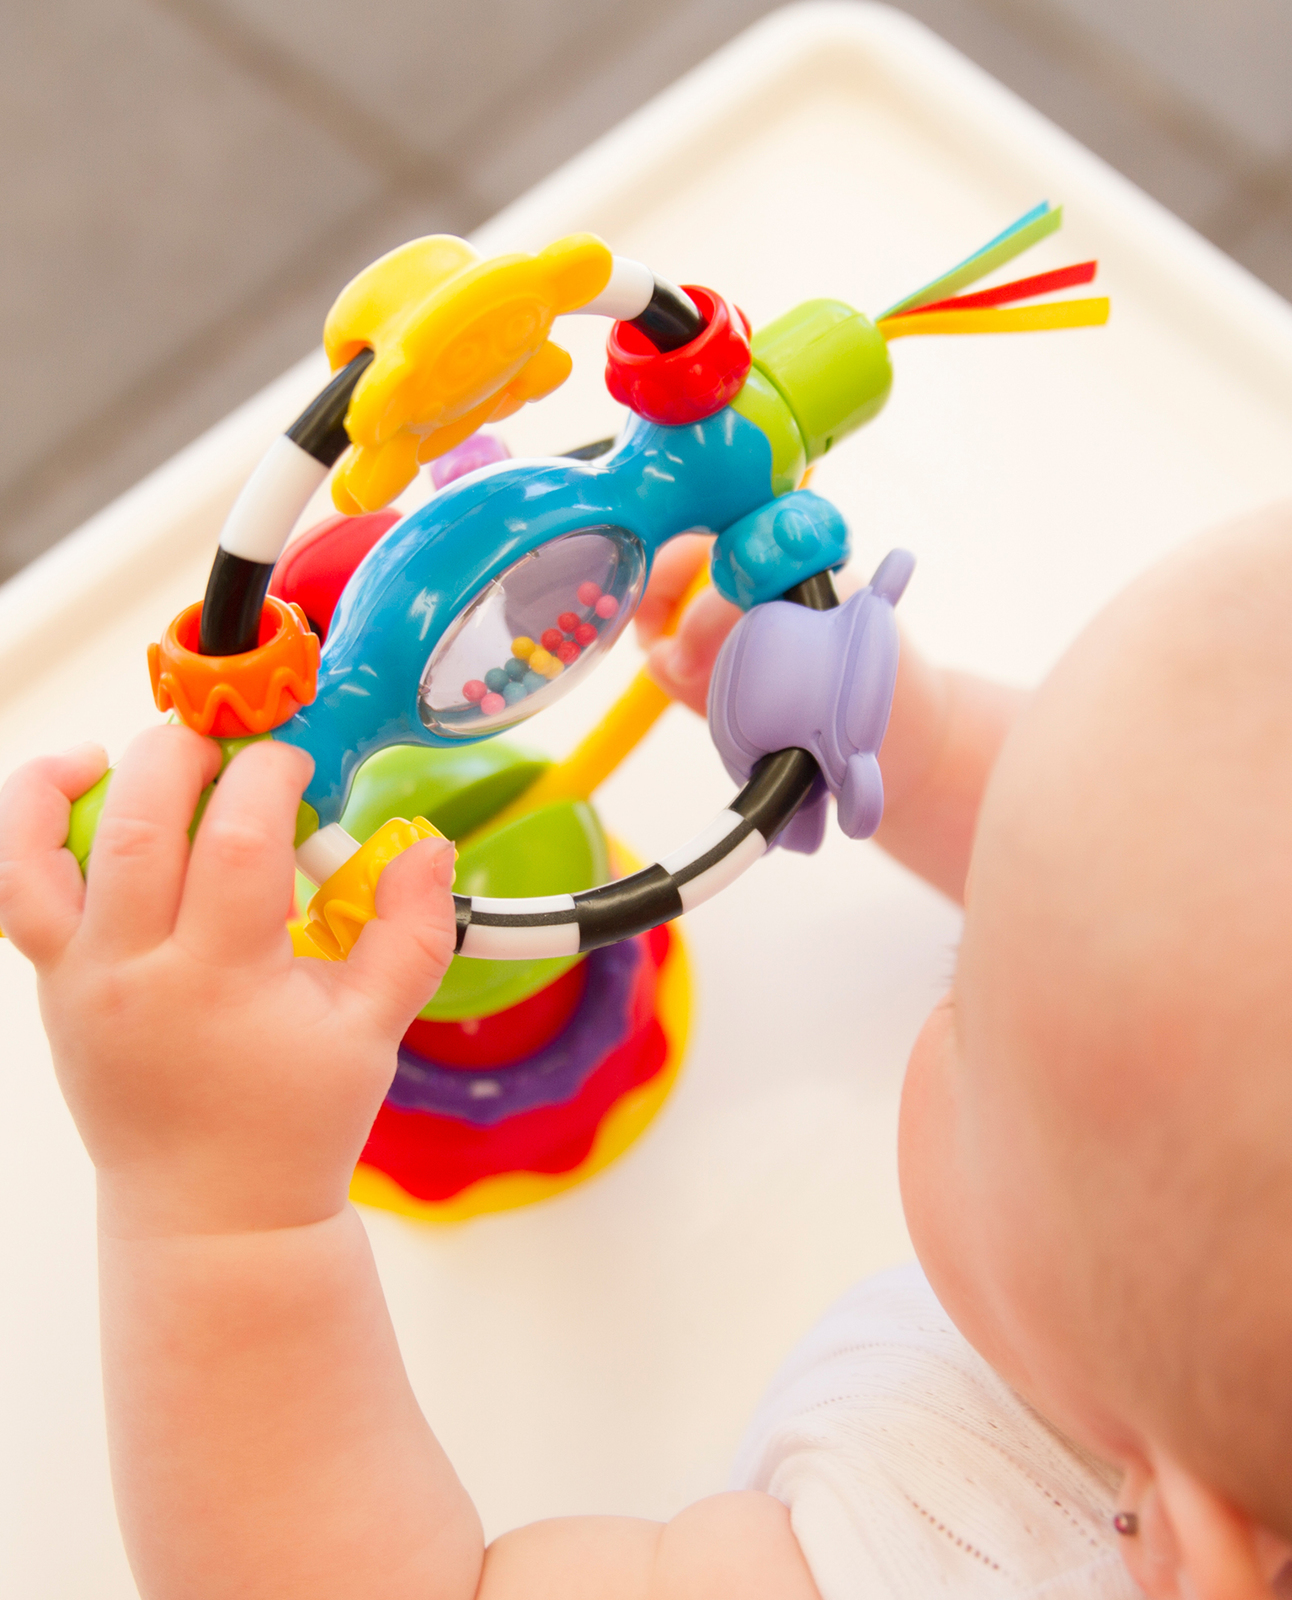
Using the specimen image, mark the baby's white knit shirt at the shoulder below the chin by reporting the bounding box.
[736,1266,1140,1600]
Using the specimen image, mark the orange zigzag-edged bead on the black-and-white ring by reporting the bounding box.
[149,595,318,739]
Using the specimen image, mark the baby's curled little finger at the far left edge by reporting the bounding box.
[0,744,107,966]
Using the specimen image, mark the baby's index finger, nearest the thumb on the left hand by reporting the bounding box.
[176,739,313,966]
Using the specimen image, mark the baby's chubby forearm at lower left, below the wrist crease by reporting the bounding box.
[99,1206,483,1600]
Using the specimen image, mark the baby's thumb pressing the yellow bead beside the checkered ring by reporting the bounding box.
[345,838,457,1037]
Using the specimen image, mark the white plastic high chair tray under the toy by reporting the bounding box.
[0,5,1292,1600]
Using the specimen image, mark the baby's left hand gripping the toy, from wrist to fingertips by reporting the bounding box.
[0,726,454,1235]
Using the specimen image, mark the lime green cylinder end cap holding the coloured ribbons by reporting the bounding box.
[753,299,892,461]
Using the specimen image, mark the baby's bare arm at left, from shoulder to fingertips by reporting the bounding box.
[0,728,815,1600]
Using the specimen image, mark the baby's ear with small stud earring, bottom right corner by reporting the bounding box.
[1119,1448,1292,1600]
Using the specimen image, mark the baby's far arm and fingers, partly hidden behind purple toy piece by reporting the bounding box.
[638,534,1025,899]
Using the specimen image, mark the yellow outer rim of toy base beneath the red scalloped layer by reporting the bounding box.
[350,926,691,1222]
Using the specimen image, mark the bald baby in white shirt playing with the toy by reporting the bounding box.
[0,510,1292,1600]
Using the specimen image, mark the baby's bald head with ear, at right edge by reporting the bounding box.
[902,510,1292,1600]
